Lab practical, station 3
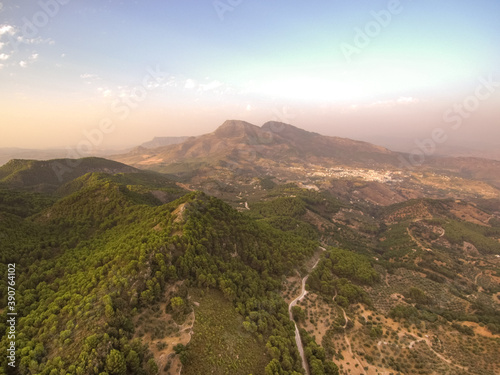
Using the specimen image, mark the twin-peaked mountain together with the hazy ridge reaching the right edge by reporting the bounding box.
[111,120,500,187]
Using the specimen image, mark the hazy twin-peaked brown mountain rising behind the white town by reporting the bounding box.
[112,120,399,171]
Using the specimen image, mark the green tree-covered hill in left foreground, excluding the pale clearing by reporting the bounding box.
[0,174,318,375]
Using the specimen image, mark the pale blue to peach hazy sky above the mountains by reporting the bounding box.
[0,0,500,152]
